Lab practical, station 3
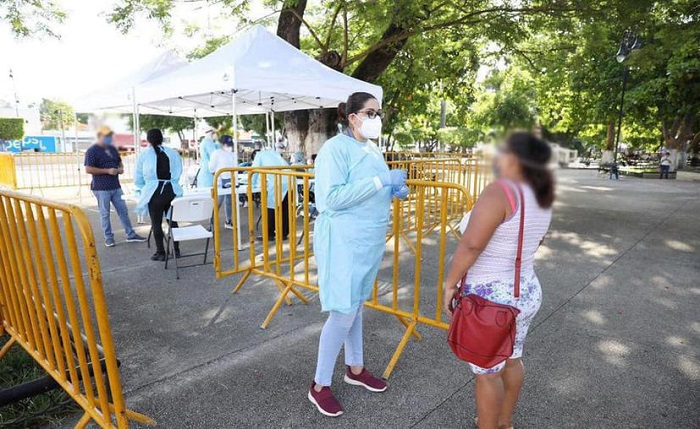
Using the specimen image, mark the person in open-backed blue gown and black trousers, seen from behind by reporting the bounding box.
[134,128,182,261]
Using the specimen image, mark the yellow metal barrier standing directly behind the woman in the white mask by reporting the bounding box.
[214,168,474,378]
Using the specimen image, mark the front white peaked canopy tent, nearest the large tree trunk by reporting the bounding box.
[137,25,383,248]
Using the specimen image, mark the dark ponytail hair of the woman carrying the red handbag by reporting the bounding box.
[506,132,554,208]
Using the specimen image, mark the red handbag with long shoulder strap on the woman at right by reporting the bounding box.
[447,186,525,368]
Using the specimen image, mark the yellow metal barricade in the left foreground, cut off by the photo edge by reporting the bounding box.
[0,191,154,429]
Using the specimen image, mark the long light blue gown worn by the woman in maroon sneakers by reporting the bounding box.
[314,134,391,313]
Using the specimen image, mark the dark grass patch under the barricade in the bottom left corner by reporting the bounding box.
[0,335,80,429]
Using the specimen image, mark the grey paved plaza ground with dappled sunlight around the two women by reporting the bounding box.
[56,171,700,429]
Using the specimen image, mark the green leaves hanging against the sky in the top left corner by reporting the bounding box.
[0,0,66,38]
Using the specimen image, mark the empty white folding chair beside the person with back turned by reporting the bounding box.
[165,195,214,279]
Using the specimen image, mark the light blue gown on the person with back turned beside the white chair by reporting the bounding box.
[134,146,182,216]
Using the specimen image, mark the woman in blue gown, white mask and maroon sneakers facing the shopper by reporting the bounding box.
[307,92,408,417]
